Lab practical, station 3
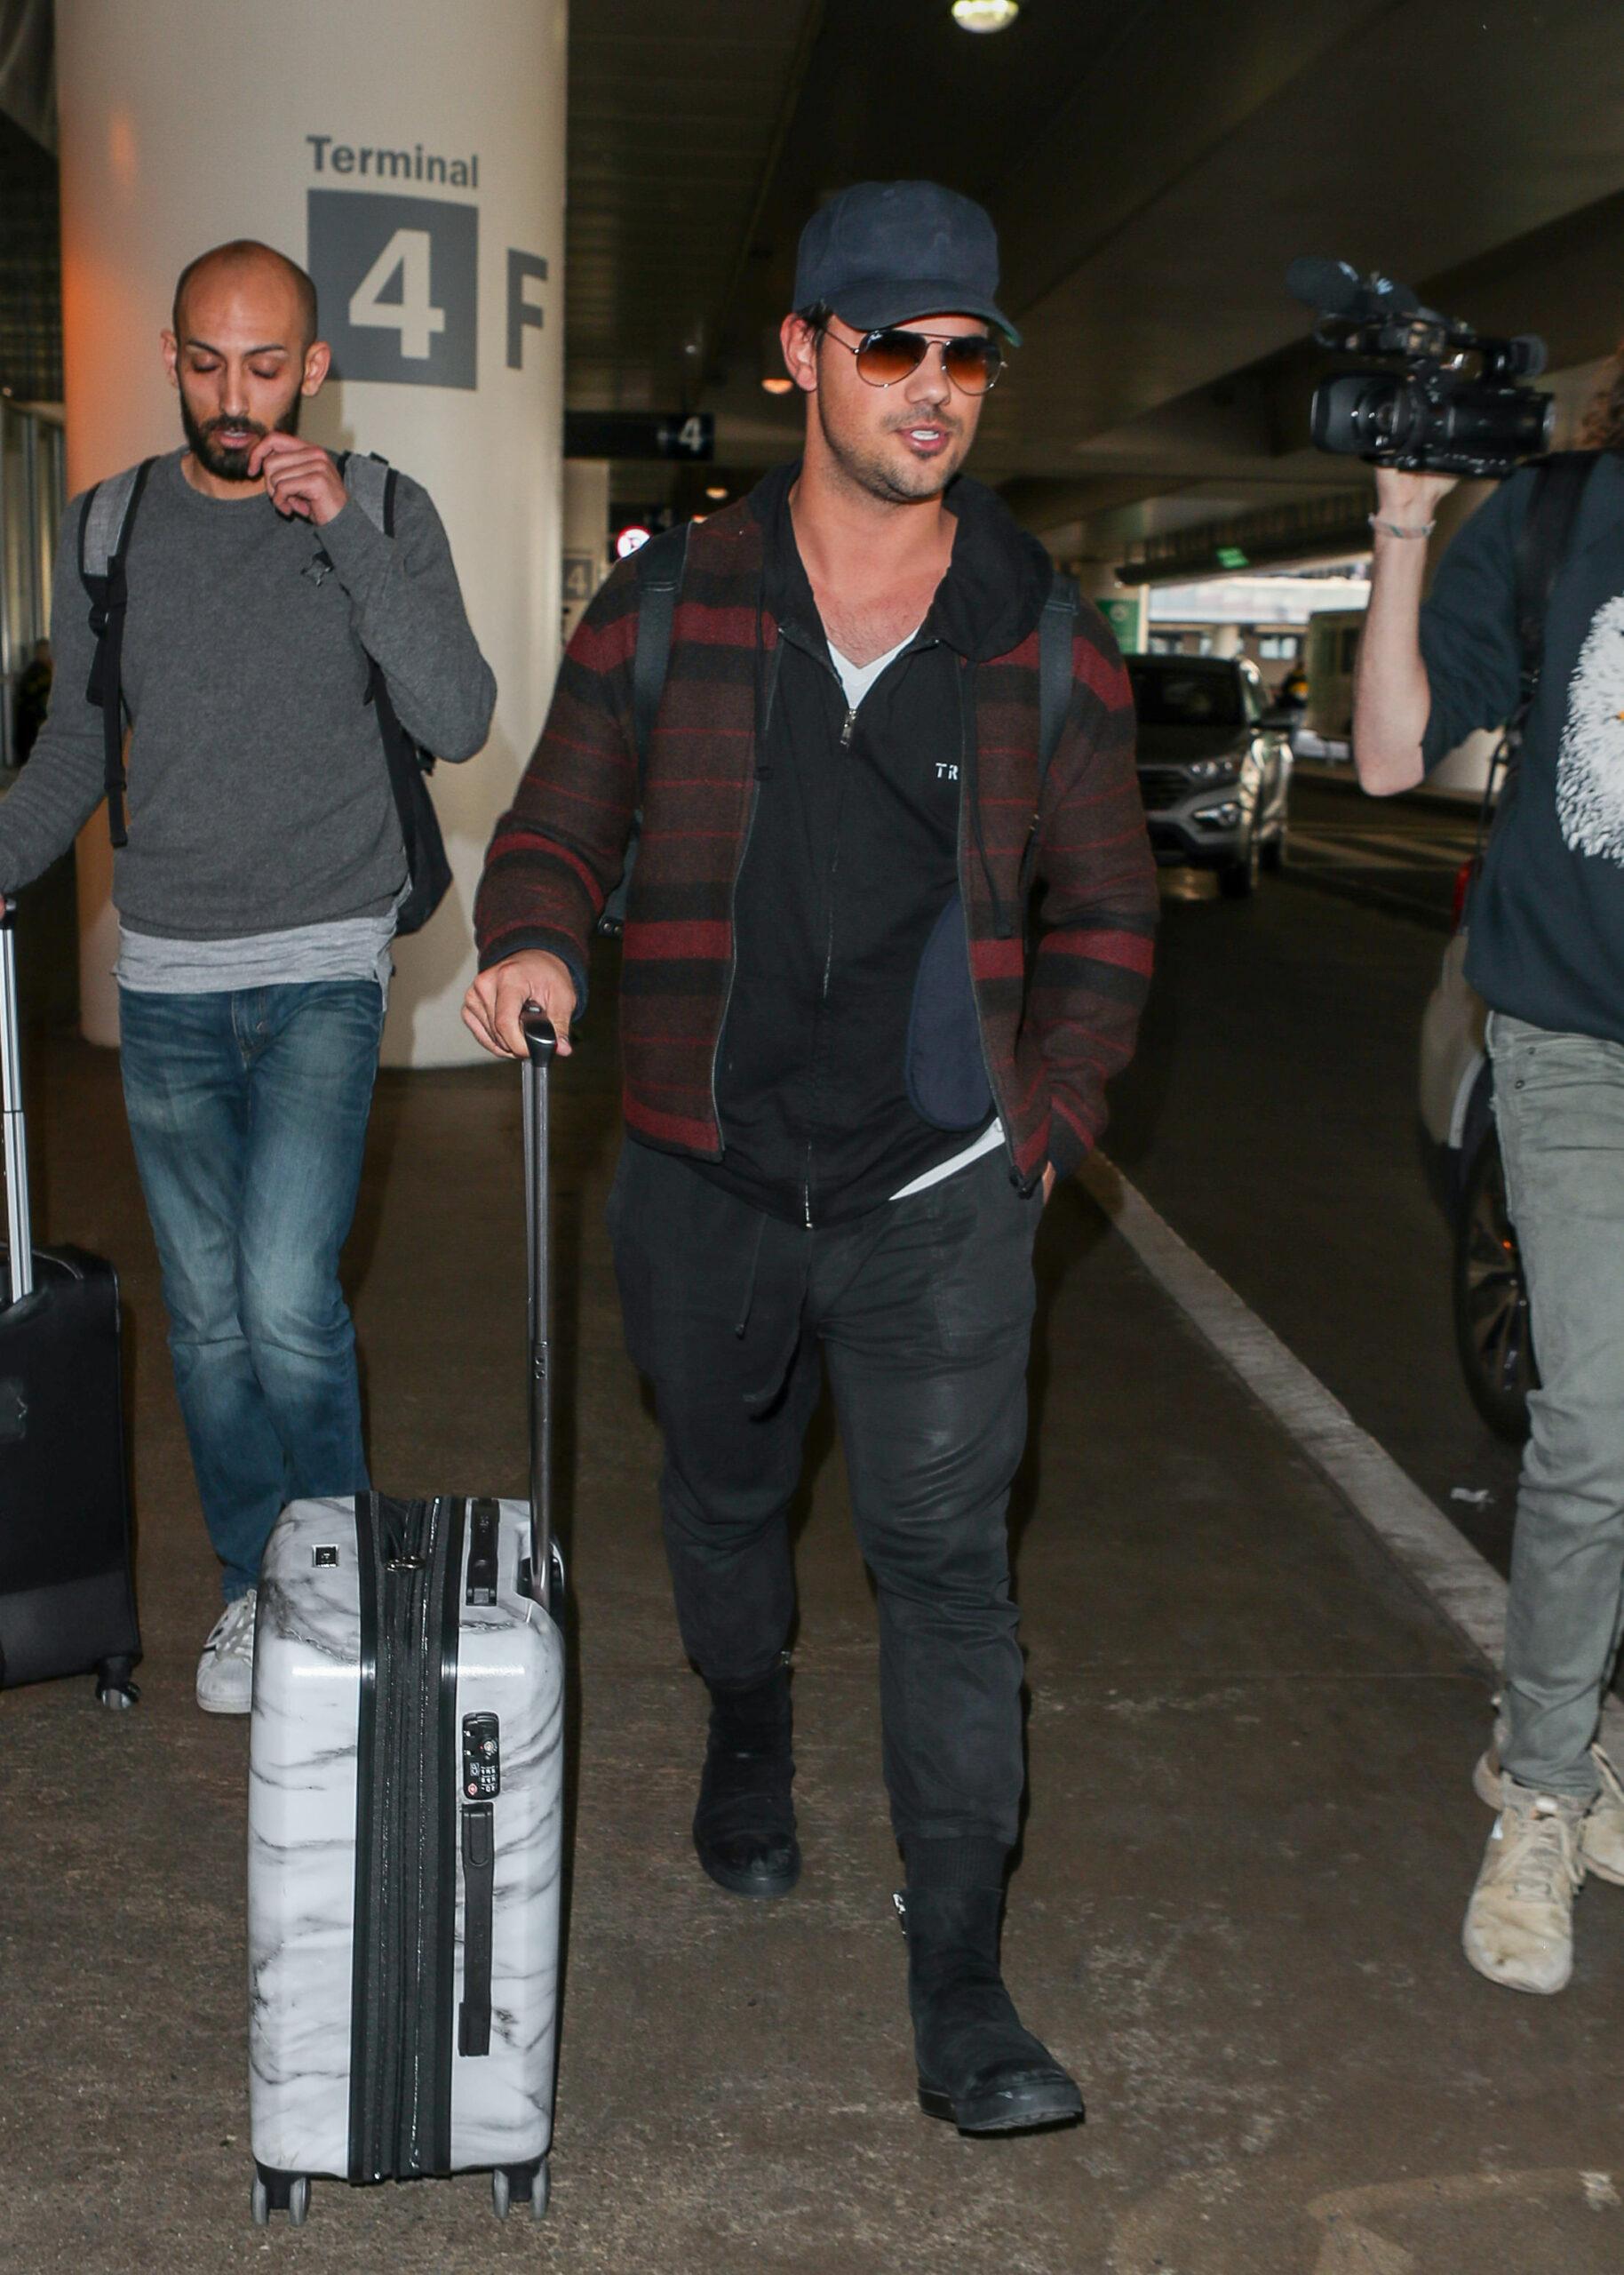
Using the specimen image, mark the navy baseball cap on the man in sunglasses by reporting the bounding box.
[794,182,1022,348]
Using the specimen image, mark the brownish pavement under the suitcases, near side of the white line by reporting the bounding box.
[0,928,1624,2275]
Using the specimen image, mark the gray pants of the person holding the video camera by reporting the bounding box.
[1487,1012,1624,1800]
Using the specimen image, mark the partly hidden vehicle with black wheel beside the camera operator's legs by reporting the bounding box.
[1420,866,1540,1438]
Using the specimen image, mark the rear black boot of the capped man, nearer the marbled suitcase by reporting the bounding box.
[694,1665,800,1895]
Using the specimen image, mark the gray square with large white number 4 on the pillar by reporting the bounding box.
[307,188,480,387]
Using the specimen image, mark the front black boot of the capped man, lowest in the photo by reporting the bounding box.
[898,1886,1083,2134]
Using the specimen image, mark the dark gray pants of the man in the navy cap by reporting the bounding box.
[609,1142,1042,1849]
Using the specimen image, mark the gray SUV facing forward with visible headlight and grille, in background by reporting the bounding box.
[1126,655,1296,898]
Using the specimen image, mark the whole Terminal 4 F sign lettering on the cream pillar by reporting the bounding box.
[305,134,548,387]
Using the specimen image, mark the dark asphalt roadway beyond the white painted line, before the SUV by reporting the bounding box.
[1105,805,1522,1569]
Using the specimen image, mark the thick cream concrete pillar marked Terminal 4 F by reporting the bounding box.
[57,0,566,1065]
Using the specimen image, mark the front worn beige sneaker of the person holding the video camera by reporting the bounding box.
[1461,1776,1585,1993]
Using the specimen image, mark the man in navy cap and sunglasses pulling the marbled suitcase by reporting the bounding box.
[466,182,1156,2134]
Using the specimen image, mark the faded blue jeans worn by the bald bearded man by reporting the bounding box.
[118,980,385,1601]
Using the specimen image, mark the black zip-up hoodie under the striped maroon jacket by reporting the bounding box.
[694,467,1053,1224]
